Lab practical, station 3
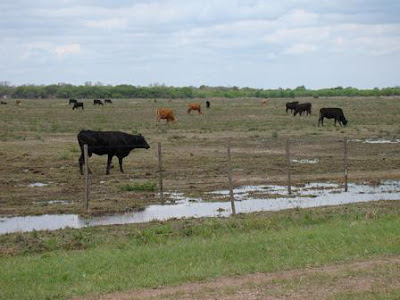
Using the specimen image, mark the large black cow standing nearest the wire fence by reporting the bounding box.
[78,130,150,175]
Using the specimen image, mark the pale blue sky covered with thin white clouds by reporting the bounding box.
[0,0,400,89]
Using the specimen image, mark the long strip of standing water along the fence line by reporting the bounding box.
[0,181,400,234]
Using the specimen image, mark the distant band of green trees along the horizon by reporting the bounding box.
[0,84,400,99]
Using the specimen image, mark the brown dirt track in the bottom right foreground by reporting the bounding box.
[76,256,400,300]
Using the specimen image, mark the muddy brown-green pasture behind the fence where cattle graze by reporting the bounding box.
[0,98,400,216]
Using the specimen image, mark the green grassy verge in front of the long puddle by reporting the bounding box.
[0,201,400,299]
